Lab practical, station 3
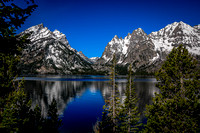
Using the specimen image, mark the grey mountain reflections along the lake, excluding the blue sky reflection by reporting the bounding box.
[25,81,158,116]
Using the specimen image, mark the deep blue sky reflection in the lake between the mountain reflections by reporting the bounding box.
[60,89,105,133]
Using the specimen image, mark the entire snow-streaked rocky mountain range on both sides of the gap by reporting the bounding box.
[19,22,200,74]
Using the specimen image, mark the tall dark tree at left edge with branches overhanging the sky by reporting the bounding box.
[0,0,37,97]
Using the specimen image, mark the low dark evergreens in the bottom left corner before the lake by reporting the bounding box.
[0,82,62,133]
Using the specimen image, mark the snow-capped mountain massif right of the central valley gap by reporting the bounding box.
[98,21,200,72]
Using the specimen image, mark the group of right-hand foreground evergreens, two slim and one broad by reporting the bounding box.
[94,45,200,133]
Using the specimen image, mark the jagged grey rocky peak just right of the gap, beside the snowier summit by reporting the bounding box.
[98,28,157,68]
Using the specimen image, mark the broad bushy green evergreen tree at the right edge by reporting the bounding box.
[145,45,200,132]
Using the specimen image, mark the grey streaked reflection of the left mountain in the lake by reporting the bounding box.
[25,81,87,116]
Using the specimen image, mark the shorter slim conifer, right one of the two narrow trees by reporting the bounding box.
[120,65,140,133]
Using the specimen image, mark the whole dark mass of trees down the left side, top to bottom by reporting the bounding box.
[0,0,61,133]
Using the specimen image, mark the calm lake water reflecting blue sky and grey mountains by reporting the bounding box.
[21,76,159,133]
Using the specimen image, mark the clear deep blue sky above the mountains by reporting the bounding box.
[17,0,200,57]
